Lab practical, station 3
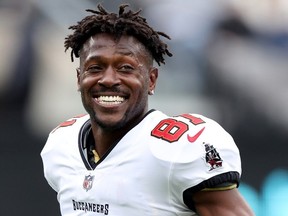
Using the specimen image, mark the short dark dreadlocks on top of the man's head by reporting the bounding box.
[64,4,172,66]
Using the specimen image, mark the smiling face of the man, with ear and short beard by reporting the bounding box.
[77,34,158,130]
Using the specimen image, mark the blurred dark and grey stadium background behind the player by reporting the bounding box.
[0,0,288,216]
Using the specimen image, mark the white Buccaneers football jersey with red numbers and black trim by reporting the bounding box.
[41,110,241,216]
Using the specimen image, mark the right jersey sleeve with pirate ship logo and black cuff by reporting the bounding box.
[170,115,241,209]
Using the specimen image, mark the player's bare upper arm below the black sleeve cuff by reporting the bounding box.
[191,188,254,216]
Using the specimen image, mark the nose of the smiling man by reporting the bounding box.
[98,66,120,87]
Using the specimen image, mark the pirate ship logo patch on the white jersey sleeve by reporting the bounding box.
[203,142,223,171]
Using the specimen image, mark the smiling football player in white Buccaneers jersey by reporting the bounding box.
[41,5,253,216]
